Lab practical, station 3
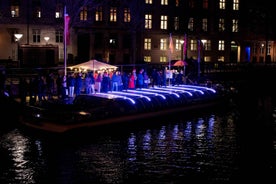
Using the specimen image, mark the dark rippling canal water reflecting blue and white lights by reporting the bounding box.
[0,98,276,184]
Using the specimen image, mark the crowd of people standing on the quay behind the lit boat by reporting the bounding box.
[8,68,190,103]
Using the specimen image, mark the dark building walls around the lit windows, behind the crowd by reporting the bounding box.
[0,0,276,68]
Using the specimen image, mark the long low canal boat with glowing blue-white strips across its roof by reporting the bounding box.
[20,85,230,133]
